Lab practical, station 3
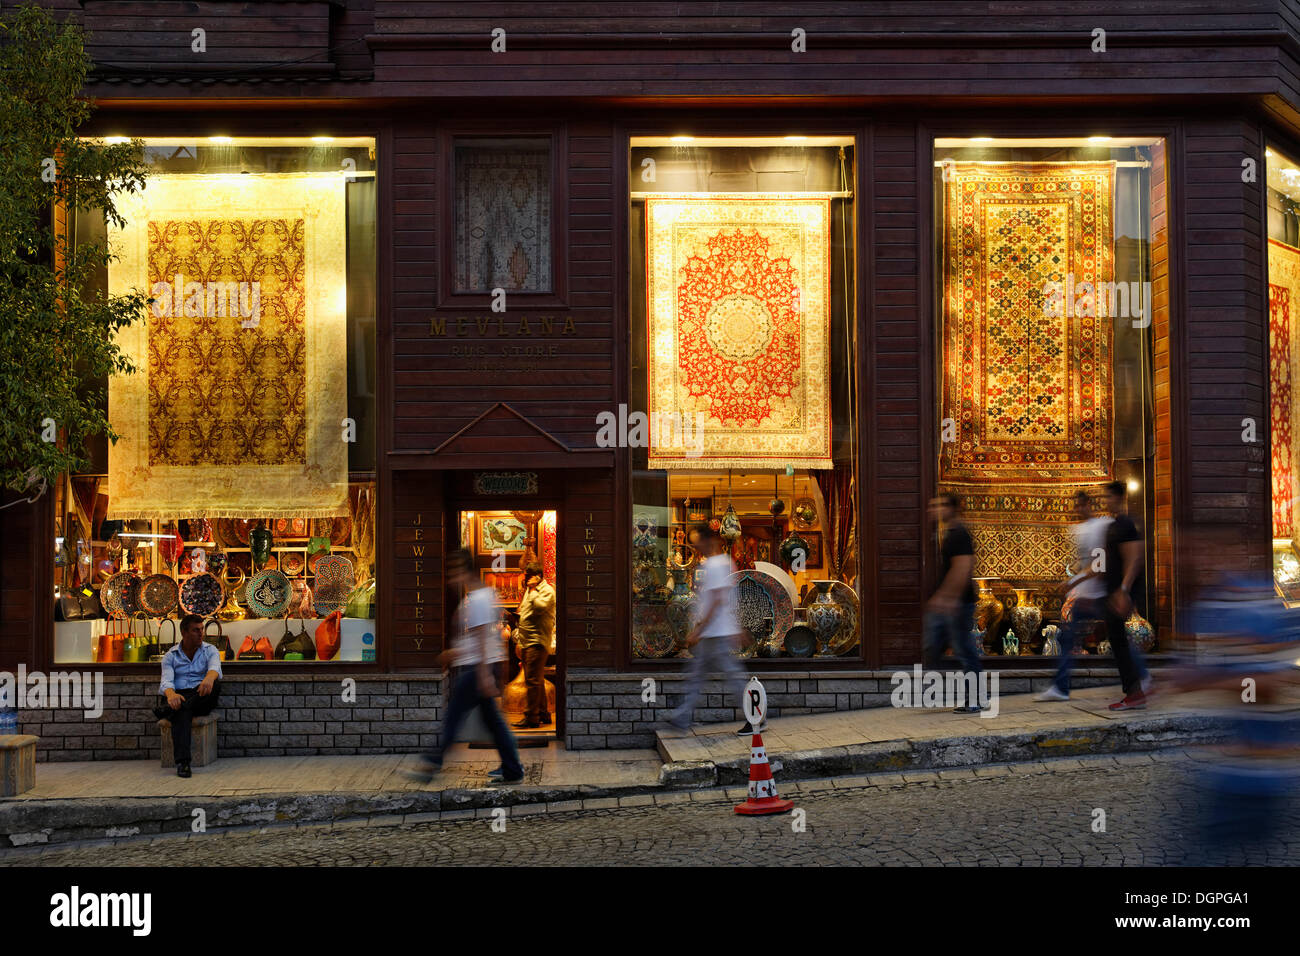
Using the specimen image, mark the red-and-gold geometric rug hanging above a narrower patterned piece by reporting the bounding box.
[939,161,1115,583]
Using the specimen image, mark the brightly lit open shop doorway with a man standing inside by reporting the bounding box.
[459,507,562,747]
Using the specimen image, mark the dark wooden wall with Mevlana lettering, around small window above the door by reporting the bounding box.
[393,112,618,451]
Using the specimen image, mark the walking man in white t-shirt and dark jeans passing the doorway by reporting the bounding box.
[412,548,524,783]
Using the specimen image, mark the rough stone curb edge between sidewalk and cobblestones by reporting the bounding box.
[0,714,1227,849]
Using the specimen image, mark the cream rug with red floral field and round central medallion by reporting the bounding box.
[646,194,832,468]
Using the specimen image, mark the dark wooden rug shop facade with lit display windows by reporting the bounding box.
[0,0,1300,760]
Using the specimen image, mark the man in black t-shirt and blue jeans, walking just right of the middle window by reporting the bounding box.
[922,494,980,714]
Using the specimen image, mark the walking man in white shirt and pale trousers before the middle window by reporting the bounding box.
[668,524,767,736]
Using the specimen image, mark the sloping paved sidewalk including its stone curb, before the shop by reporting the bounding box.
[0,688,1237,848]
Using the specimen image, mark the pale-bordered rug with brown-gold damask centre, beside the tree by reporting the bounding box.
[108,173,348,519]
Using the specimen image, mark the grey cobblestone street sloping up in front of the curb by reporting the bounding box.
[0,753,1300,866]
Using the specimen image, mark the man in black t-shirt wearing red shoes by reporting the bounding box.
[1102,481,1151,710]
